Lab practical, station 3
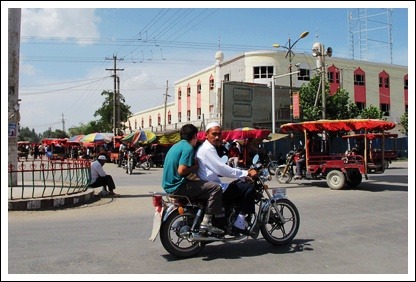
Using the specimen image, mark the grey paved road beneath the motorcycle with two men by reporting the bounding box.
[6,162,414,280]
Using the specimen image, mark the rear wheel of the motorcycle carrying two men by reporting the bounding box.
[160,210,205,258]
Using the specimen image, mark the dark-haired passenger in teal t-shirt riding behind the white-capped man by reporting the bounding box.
[162,124,224,234]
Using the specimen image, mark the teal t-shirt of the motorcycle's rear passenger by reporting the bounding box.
[162,140,195,193]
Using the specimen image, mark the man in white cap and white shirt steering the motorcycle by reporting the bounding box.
[196,122,258,235]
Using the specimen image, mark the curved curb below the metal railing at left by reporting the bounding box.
[9,189,94,211]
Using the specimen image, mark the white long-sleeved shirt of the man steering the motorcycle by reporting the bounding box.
[195,140,248,191]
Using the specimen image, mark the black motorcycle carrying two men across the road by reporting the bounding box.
[149,156,300,258]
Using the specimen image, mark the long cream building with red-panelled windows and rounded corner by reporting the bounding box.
[126,51,408,135]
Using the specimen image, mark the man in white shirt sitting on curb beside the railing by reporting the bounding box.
[89,155,119,197]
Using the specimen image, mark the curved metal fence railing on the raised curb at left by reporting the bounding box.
[8,160,91,200]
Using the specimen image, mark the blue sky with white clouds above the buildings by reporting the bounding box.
[2,1,414,133]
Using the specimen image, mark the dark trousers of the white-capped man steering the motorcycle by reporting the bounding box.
[222,180,256,214]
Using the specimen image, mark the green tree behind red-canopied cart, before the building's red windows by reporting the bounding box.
[300,76,360,121]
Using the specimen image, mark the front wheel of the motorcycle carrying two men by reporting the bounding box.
[260,199,300,246]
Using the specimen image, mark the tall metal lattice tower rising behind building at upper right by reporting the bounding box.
[348,9,393,64]
